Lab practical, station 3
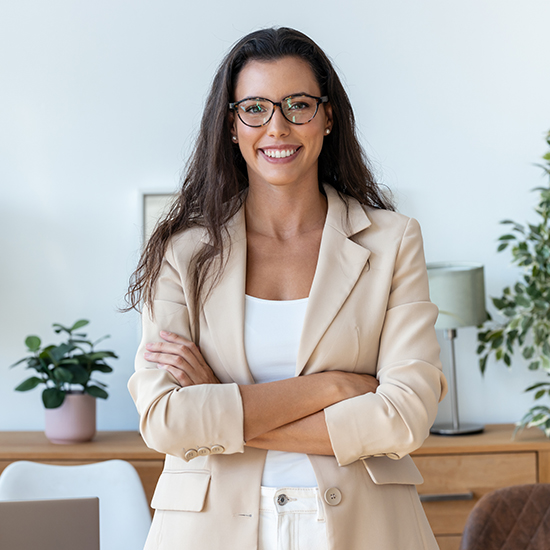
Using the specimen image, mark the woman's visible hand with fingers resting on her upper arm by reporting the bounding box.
[144,330,220,387]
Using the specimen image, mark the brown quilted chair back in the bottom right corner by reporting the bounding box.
[460,483,550,550]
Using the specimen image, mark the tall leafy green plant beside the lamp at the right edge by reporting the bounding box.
[477,132,550,437]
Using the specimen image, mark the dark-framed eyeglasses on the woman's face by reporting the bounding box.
[229,94,328,128]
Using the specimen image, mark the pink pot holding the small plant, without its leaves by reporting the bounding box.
[45,392,96,445]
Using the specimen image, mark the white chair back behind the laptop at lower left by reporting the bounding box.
[0,460,151,550]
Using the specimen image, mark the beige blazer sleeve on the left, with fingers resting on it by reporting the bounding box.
[128,247,244,461]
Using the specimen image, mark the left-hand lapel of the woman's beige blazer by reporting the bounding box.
[204,206,254,384]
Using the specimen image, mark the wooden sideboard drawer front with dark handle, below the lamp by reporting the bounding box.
[413,452,537,535]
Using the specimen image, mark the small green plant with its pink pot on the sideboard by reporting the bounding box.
[12,319,117,443]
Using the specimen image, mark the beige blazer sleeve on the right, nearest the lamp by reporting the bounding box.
[325,219,447,466]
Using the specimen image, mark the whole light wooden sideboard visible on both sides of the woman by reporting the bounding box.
[0,424,550,550]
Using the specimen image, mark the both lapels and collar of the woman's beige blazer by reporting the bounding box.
[204,185,371,384]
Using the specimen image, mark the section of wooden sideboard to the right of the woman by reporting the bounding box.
[412,424,550,550]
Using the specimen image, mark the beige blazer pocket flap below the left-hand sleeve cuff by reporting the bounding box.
[151,471,210,512]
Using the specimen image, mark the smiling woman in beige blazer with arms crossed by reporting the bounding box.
[129,28,445,550]
